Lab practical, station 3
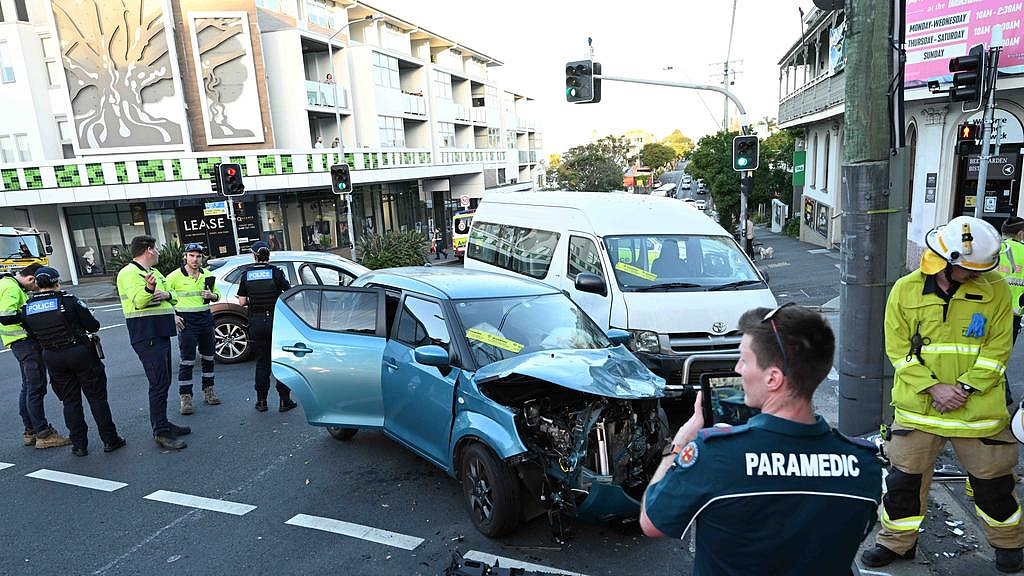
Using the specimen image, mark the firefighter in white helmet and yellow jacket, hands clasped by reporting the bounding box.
[861,216,1024,572]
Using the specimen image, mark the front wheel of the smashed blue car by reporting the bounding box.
[459,444,519,538]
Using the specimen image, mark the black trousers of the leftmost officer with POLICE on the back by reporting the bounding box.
[43,342,118,448]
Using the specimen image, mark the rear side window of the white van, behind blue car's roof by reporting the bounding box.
[466,221,559,278]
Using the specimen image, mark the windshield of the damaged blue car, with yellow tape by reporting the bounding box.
[455,294,610,366]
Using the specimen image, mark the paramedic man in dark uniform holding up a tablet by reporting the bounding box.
[640,305,882,576]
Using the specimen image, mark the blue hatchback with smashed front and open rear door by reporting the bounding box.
[272,266,671,536]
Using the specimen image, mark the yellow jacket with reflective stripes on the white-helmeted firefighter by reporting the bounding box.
[885,269,1013,438]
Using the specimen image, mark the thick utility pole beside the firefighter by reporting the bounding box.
[839,0,906,436]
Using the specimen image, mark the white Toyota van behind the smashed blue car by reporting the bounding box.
[465,192,776,390]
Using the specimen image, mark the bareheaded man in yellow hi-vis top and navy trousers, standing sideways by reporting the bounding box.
[118,236,191,450]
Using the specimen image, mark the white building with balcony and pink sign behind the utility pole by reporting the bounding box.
[778,0,1024,260]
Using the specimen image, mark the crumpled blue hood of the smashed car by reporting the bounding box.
[474,345,665,400]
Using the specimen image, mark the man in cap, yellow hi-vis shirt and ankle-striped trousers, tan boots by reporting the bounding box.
[167,242,220,414]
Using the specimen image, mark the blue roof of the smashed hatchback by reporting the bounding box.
[353,265,559,300]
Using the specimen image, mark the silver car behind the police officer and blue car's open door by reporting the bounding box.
[207,251,370,364]
